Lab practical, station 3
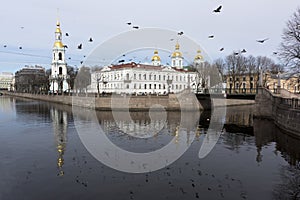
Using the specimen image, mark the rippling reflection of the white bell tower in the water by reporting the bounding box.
[50,108,68,176]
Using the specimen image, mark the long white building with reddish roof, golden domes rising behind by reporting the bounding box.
[90,43,202,95]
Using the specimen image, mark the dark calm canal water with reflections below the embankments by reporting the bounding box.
[0,96,300,200]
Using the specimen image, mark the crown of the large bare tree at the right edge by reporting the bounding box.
[279,8,300,71]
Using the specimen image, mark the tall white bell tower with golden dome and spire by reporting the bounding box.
[50,21,69,93]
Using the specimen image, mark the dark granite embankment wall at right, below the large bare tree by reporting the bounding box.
[254,88,300,138]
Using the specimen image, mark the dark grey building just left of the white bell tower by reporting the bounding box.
[15,65,49,93]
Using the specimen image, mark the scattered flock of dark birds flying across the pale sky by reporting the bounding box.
[3,5,277,67]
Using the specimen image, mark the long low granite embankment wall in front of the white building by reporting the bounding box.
[4,92,203,111]
